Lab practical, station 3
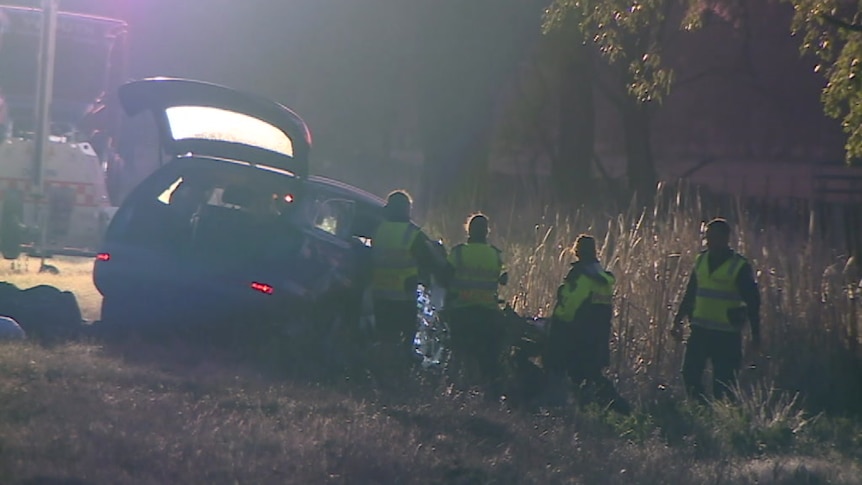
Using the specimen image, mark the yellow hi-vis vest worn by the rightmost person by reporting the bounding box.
[691,253,746,332]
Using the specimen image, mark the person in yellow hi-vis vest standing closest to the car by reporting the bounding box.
[371,190,446,351]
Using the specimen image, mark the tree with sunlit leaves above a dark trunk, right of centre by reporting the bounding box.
[543,0,710,201]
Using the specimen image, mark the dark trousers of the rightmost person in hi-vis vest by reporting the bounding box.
[682,326,742,401]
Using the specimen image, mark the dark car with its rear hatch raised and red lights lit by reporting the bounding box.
[94,78,383,336]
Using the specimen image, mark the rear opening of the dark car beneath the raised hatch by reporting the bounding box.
[108,159,299,259]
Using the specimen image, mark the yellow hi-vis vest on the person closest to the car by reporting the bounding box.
[371,221,420,300]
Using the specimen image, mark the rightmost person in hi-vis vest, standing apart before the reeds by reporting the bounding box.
[671,218,760,401]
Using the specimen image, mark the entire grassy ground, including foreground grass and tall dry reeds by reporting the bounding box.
[0,187,862,484]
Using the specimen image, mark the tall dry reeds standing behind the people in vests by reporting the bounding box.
[429,185,862,411]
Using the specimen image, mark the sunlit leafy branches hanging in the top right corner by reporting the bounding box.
[785,0,862,164]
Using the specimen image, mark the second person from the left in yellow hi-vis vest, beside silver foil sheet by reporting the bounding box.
[446,214,508,390]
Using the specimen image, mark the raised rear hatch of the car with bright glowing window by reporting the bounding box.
[118,78,311,178]
